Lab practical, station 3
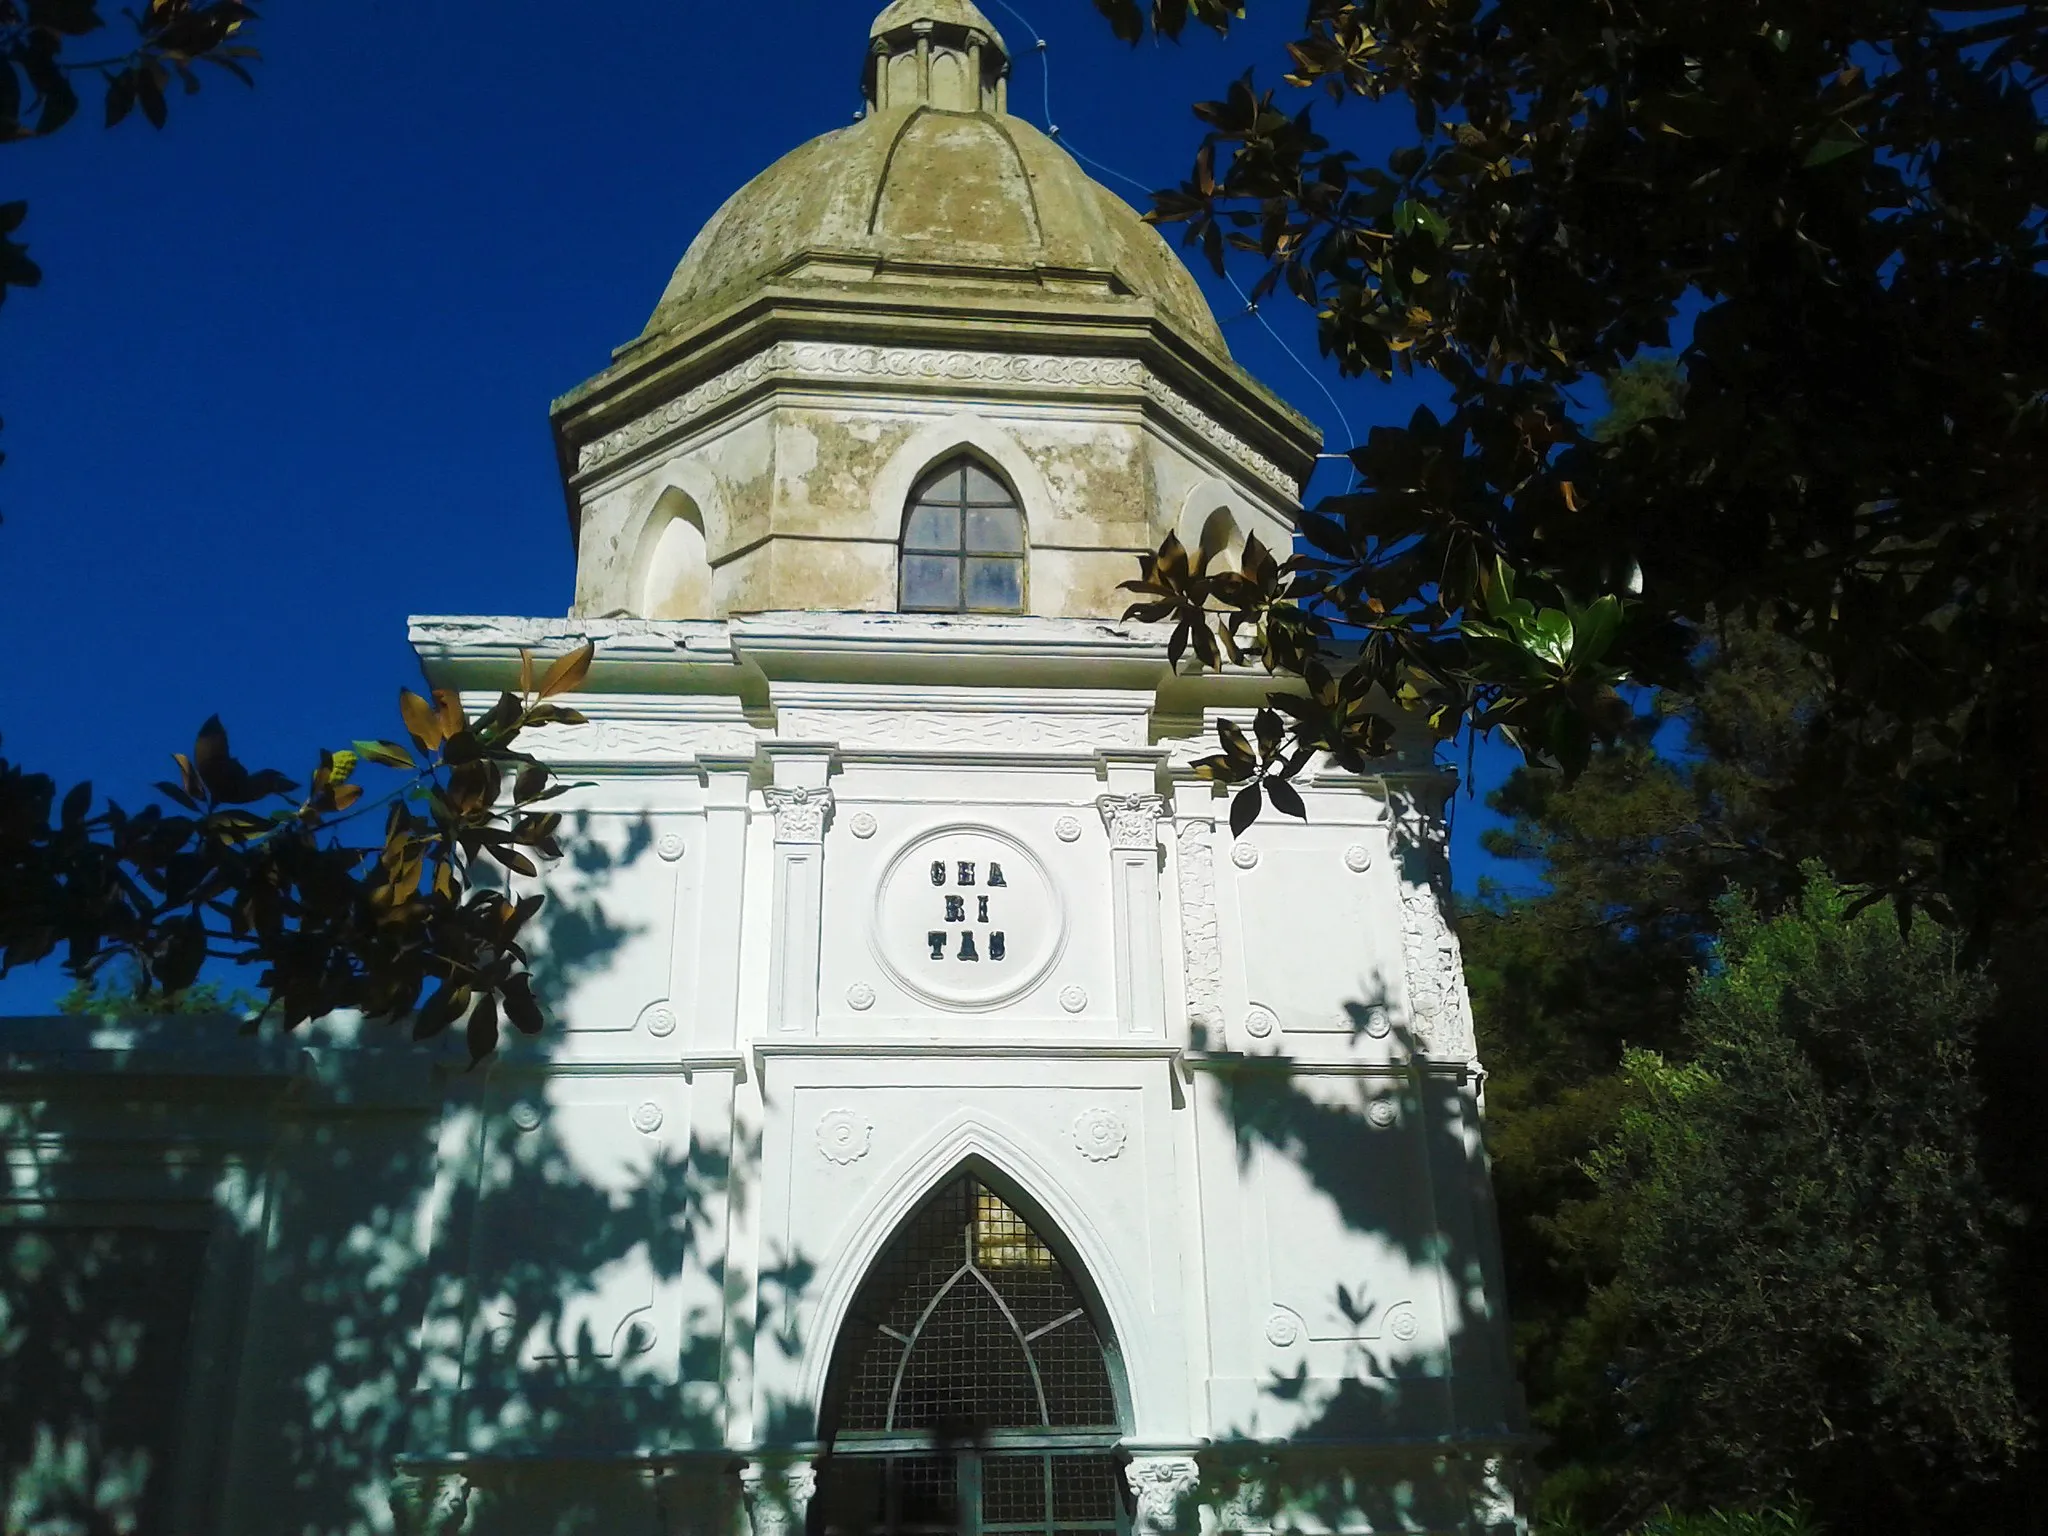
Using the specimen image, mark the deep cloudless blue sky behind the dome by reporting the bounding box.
[0,0,1501,1012]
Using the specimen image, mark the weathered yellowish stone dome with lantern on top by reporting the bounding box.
[647,0,1229,358]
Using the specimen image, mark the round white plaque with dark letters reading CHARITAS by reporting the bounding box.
[868,823,1067,1012]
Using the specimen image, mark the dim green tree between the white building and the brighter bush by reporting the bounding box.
[1458,625,1819,1511]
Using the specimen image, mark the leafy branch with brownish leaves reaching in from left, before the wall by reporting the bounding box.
[0,645,594,1059]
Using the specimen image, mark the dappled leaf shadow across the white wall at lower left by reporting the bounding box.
[0,834,823,1536]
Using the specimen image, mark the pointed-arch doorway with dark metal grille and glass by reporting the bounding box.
[811,1171,1130,1536]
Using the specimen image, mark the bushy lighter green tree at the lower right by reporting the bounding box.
[1585,868,2028,1532]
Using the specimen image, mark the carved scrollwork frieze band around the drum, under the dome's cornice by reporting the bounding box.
[575,342,1300,498]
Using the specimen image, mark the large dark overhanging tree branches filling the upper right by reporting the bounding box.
[1108,0,2048,962]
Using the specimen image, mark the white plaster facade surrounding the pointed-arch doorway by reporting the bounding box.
[0,621,1516,1536]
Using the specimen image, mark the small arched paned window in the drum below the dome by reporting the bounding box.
[897,459,1024,612]
